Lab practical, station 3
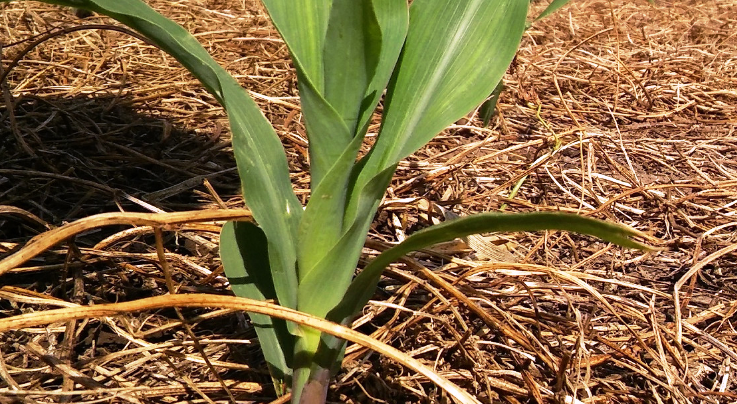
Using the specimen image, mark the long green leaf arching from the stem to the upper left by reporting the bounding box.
[8,0,302,308]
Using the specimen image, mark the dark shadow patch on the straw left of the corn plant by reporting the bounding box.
[0,95,239,240]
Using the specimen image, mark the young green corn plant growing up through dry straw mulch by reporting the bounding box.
[2,0,643,403]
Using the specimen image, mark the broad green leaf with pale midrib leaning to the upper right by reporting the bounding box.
[344,0,528,256]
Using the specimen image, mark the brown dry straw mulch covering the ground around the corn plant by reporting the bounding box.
[0,0,737,403]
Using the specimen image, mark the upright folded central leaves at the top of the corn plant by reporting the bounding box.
[264,0,408,186]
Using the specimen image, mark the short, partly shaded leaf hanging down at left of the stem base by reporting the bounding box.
[220,222,295,388]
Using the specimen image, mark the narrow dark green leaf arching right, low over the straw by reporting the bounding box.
[326,212,650,322]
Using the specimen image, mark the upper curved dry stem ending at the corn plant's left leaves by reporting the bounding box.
[0,209,251,275]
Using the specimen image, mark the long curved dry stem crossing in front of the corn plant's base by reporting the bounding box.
[0,294,479,404]
